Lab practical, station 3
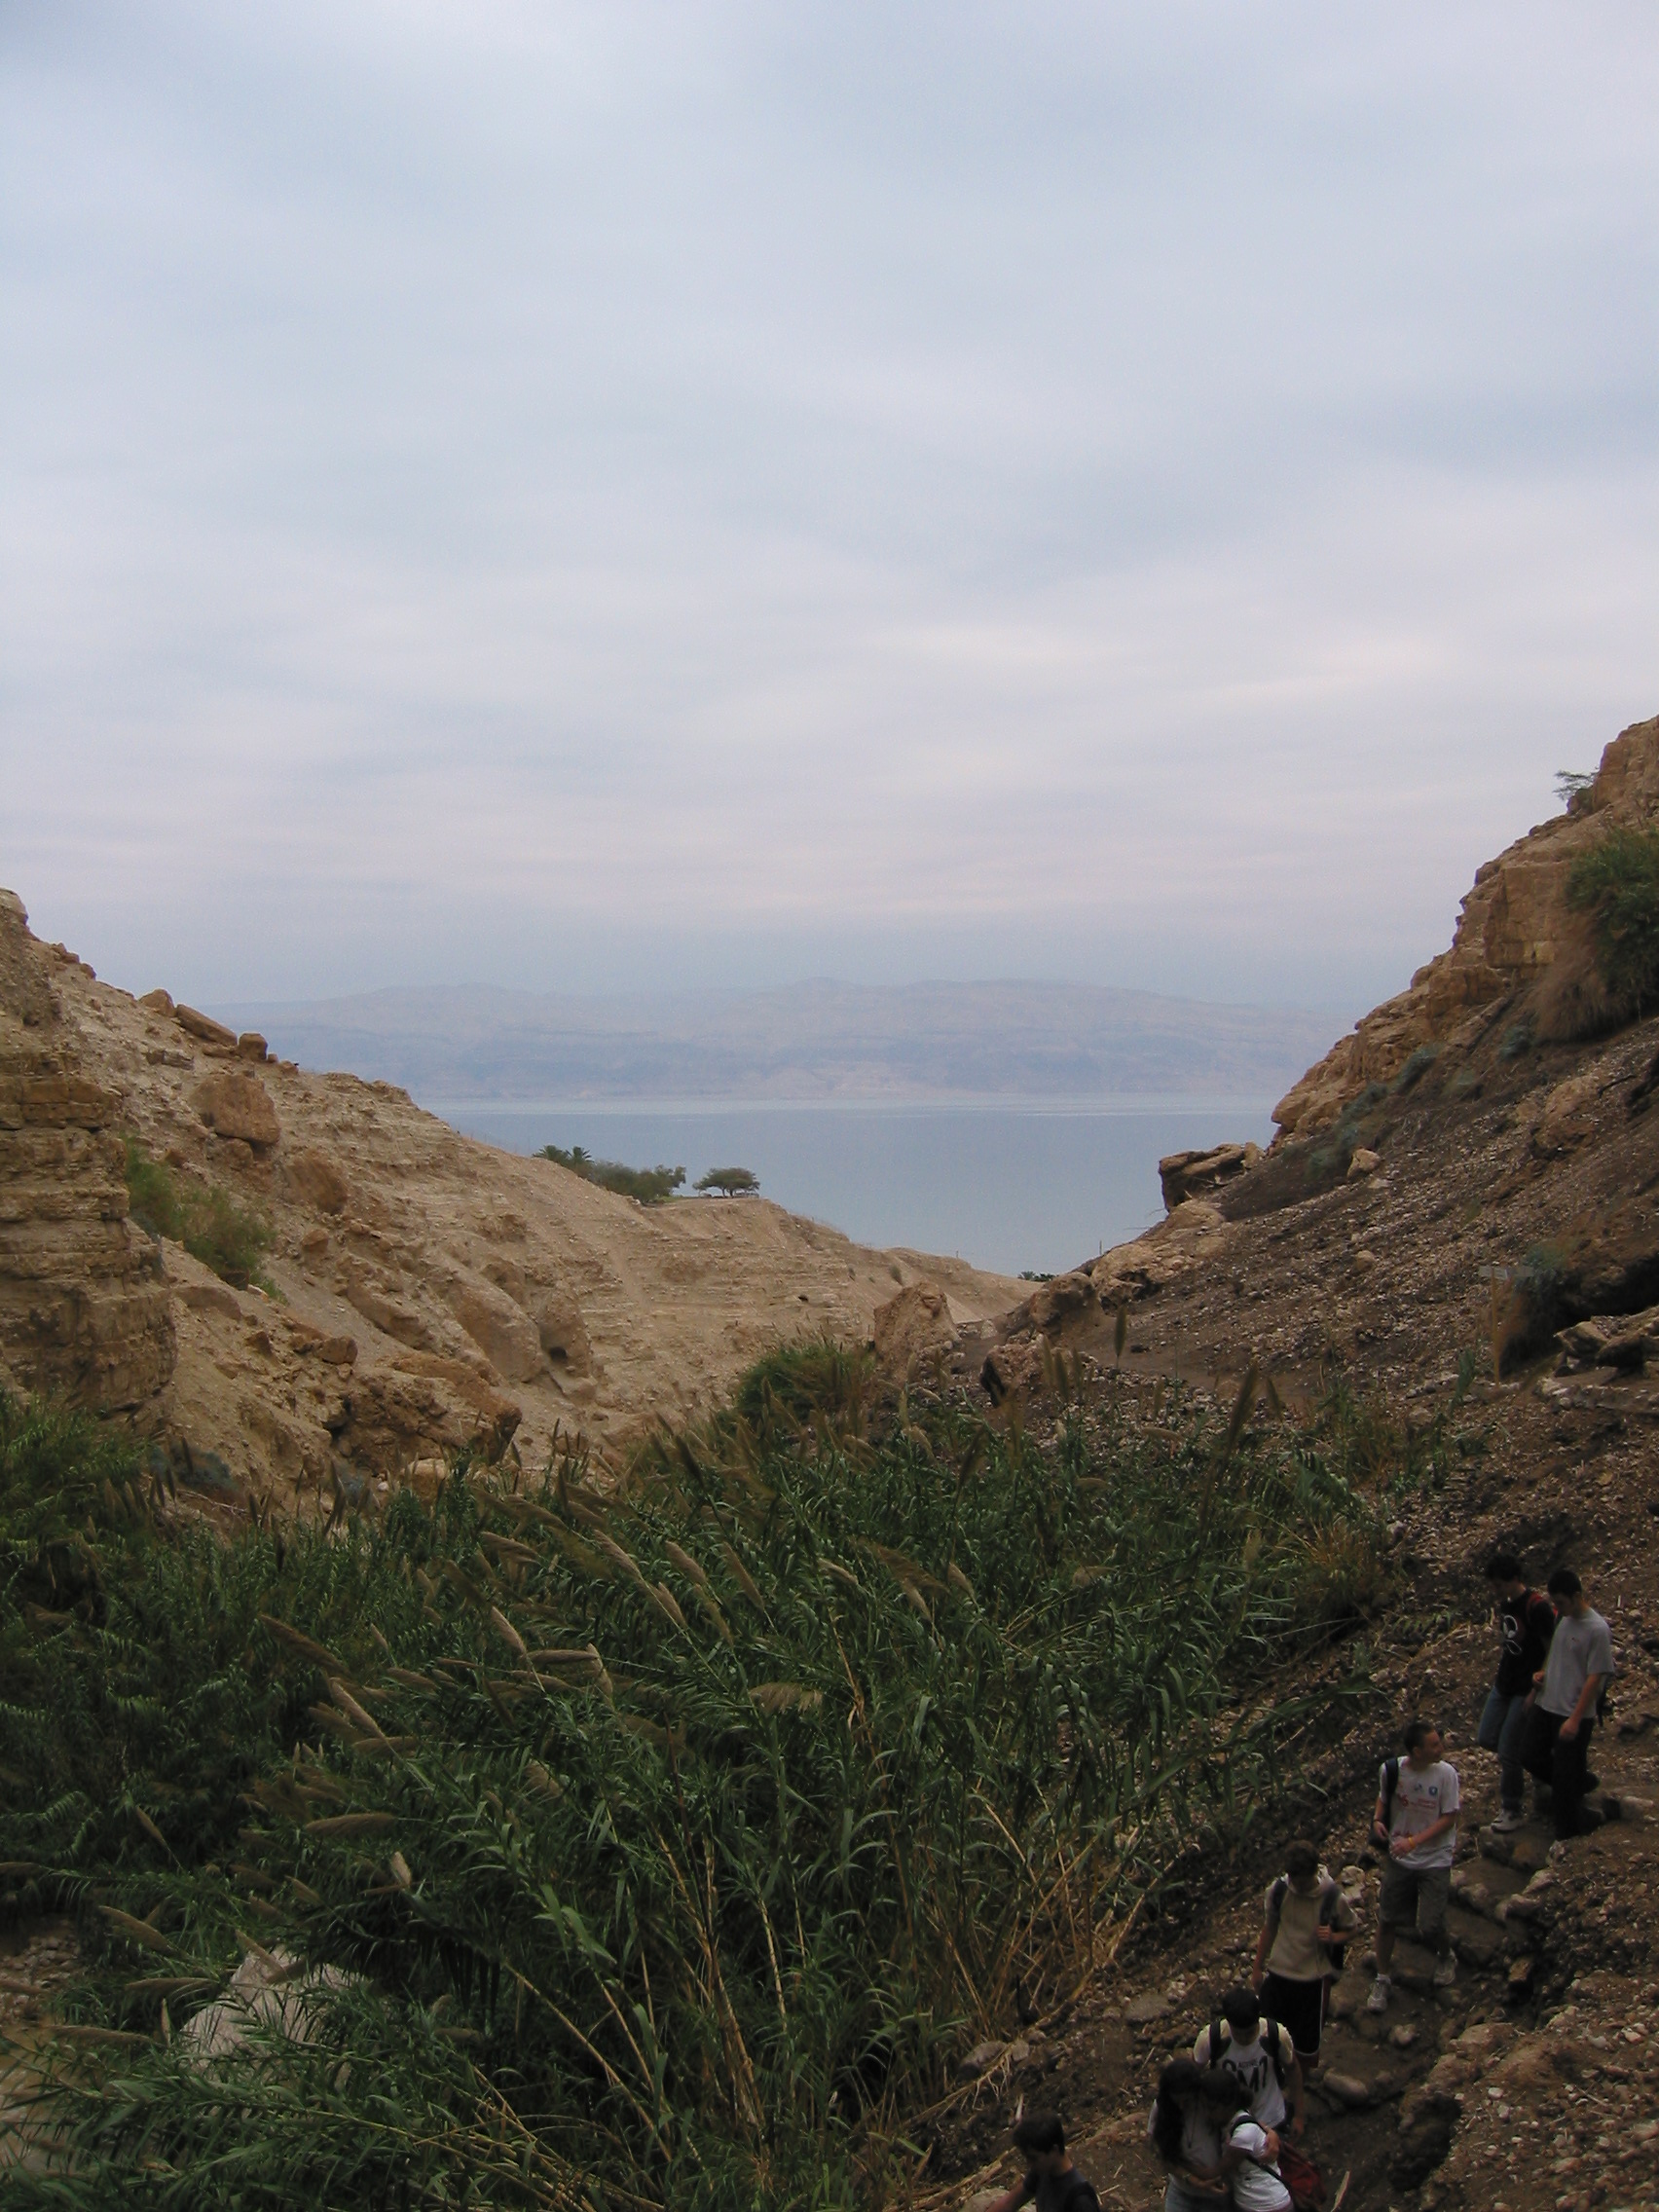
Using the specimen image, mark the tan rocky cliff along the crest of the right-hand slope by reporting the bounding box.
[1274,717,1659,1137]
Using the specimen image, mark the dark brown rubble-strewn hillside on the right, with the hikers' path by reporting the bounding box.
[929,721,1659,2212]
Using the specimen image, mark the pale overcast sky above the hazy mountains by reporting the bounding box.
[0,0,1659,1017]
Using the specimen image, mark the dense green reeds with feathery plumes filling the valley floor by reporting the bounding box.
[0,1347,1393,2207]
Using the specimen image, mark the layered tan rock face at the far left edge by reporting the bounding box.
[0,892,177,1409]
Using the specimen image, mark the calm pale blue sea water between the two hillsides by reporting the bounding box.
[423,1097,1272,1274]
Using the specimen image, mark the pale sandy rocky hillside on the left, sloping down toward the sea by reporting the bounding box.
[0,892,1019,1497]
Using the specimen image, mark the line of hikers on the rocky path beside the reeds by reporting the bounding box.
[991,1551,1615,2212]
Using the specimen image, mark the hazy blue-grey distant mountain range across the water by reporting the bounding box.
[217,982,1334,1104]
